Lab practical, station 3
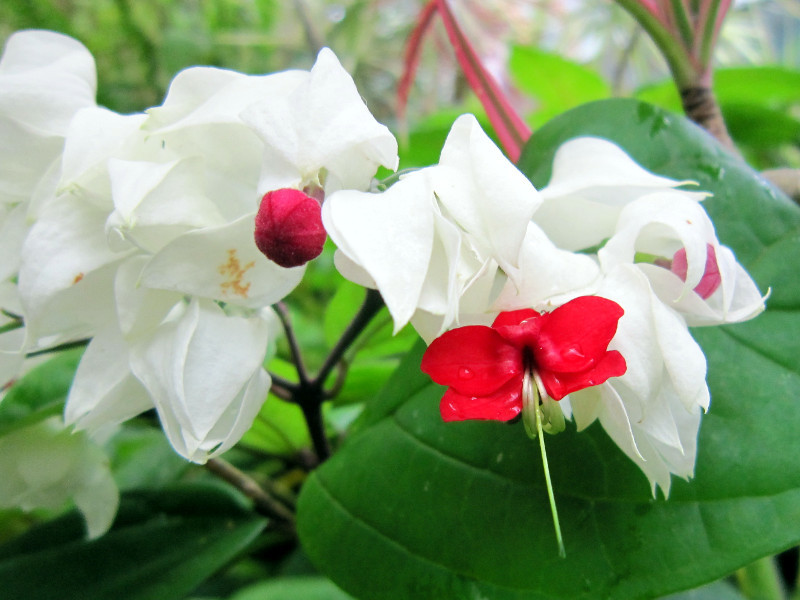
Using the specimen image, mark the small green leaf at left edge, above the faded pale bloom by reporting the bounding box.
[0,348,83,435]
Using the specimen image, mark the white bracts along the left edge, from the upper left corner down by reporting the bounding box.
[0,31,96,394]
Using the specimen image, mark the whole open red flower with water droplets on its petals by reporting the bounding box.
[422,296,627,421]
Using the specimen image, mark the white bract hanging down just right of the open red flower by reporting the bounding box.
[561,264,709,495]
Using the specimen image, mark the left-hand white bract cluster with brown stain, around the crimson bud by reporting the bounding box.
[0,31,398,474]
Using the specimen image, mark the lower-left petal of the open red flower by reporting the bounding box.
[439,376,522,422]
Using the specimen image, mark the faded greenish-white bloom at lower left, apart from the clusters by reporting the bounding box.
[0,417,119,538]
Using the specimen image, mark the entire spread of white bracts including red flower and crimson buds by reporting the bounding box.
[0,32,764,528]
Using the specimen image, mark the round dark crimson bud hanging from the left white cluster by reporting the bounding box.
[255,189,327,268]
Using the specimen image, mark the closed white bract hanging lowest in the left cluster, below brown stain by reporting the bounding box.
[131,300,271,462]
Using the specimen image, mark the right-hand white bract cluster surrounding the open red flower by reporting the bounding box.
[323,115,764,494]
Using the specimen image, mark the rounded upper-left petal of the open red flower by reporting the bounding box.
[421,325,522,396]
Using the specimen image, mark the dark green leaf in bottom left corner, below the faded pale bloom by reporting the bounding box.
[0,485,265,600]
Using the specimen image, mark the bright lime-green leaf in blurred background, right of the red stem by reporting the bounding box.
[509,46,611,127]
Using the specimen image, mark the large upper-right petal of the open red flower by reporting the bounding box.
[533,296,624,370]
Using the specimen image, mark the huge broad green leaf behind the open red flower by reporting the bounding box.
[299,100,800,600]
